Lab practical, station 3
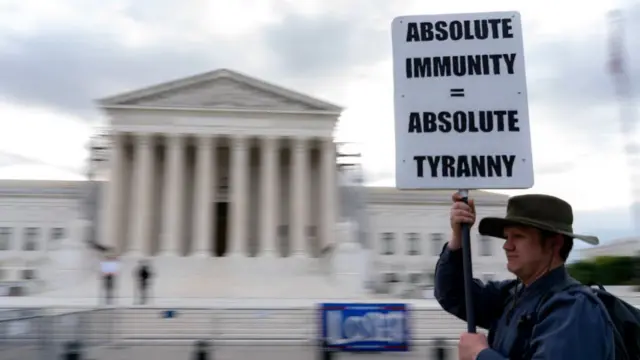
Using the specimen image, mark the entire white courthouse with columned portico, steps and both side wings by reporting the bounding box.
[0,69,508,297]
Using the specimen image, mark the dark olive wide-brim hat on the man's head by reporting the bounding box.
[478,194,600,245]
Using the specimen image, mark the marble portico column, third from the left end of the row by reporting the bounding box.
[160,134,185,256]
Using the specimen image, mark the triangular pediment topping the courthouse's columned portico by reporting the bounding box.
[99,69,342,113]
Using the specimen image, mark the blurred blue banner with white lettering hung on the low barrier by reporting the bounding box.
[320,303,410,352]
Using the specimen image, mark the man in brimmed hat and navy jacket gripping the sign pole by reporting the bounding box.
[435,194,615,360]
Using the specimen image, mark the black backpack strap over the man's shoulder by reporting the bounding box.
[509,279,584,360]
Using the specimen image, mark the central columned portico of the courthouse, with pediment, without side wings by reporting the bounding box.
[100,69,342,257]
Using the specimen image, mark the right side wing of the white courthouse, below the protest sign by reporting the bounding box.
[367,188,512,296]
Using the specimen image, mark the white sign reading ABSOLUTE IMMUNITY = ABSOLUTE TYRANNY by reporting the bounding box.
[392,12,533,189]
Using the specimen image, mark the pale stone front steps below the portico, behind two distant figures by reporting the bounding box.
[35,257,367,304]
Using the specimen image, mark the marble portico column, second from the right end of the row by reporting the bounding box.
[289,138,309,257]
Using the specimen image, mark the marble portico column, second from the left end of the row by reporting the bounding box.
[129,134,154,256]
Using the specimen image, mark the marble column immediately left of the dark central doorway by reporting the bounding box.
[192,135,216,257]
